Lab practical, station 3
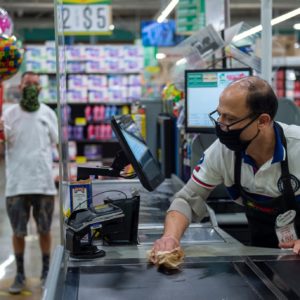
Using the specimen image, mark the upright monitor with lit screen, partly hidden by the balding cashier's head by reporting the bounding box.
[185,68,252,133]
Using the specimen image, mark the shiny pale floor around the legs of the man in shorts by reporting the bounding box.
[0,160,60,300]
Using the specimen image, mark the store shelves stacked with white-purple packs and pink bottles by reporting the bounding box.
[25,42,143,178]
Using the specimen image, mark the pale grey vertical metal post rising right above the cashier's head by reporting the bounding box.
[260,0,272,84]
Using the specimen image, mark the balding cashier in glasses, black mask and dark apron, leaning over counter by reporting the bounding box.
[152,76,300,254]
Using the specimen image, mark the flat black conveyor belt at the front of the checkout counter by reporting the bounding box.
[59,258,300,300]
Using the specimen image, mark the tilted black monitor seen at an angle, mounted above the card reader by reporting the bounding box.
[111,115,164,191]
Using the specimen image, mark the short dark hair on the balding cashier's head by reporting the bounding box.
[240,76,278,120]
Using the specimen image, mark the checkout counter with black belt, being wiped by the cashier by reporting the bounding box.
[43,177,300,300]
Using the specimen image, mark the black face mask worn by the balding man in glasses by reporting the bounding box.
[216,116,259,152]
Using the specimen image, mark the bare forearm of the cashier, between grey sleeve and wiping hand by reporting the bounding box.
[163,210,189,242]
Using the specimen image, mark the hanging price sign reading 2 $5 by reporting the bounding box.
[58,0,112,35]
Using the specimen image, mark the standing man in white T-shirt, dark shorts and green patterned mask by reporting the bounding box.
[0,72,58,294]
